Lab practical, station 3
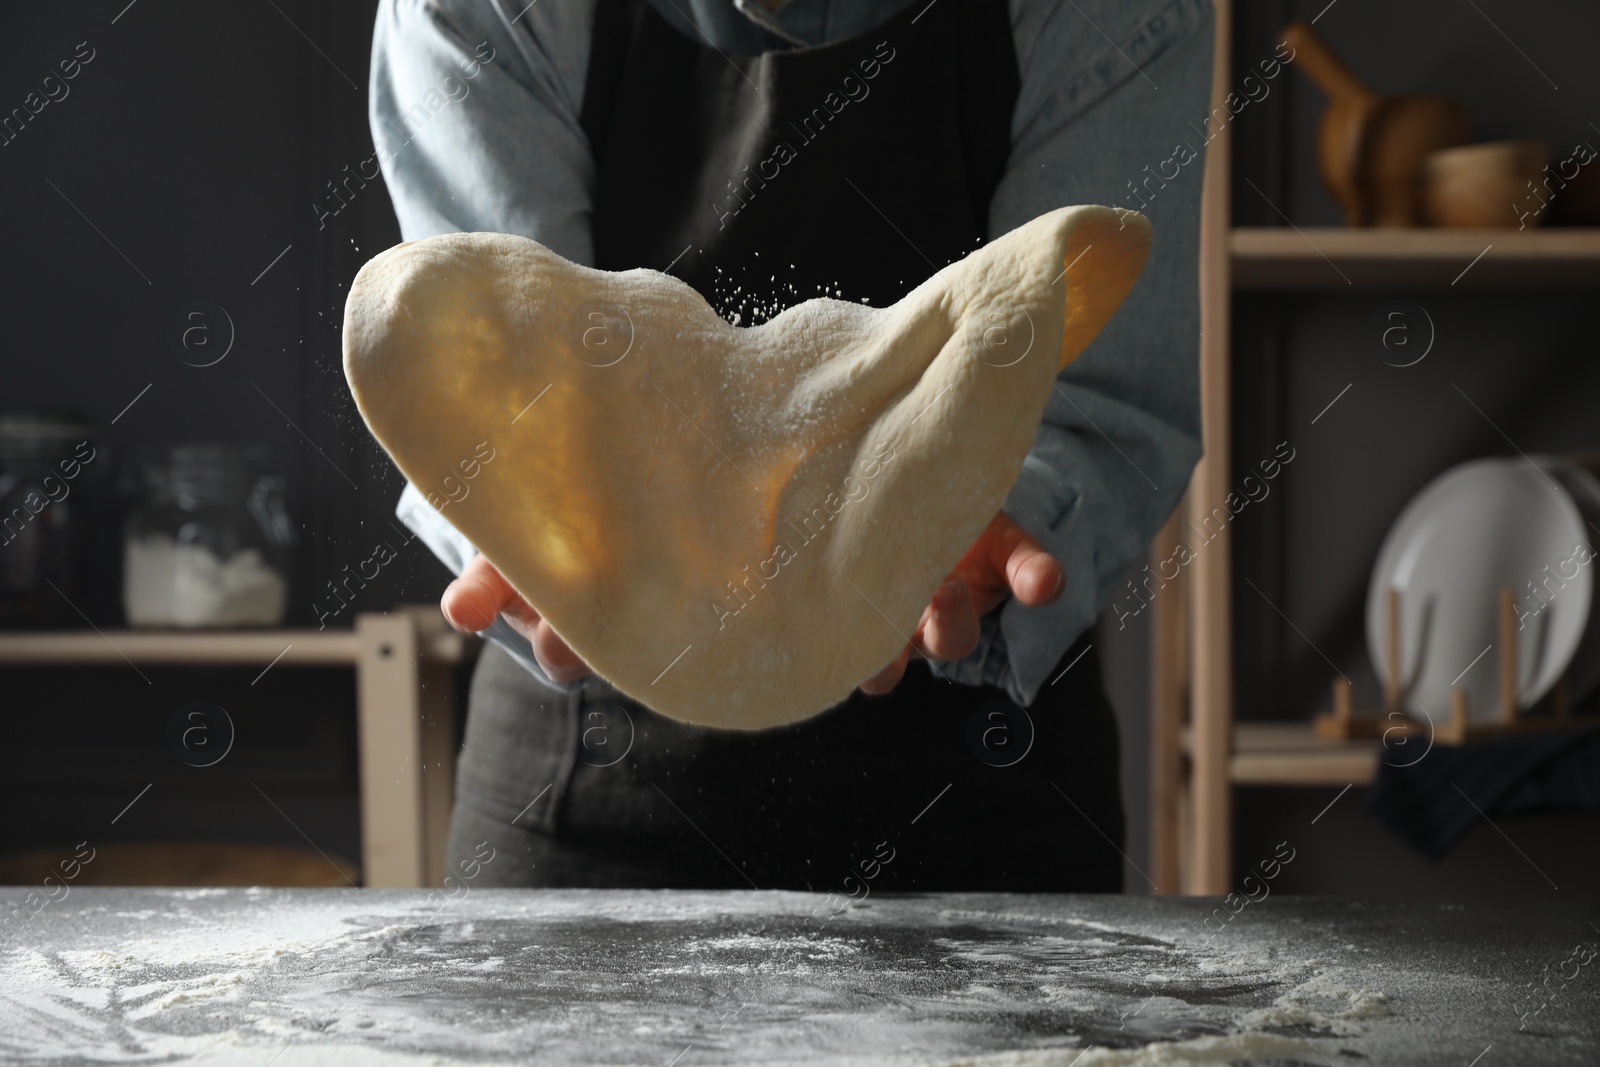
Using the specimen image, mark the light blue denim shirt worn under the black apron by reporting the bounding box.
[366,0,1214,704]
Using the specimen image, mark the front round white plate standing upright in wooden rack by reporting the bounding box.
[1366,458,1594,721]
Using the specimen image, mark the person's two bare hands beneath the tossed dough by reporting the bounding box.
[438,512,1067,694]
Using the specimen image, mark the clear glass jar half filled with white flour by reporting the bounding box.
[122,445,294,629]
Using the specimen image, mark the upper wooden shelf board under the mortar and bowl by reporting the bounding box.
[1229,227,1600,293]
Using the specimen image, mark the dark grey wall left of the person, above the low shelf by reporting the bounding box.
[0,0,438,625]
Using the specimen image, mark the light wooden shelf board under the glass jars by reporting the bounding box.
[0,630,467,667]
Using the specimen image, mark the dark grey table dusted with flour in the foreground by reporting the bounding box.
[0,888,1600,1067]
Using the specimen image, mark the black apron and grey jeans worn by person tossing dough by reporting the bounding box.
[450,0,1123,899]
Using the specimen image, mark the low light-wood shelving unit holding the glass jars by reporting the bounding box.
[0,606,477,888]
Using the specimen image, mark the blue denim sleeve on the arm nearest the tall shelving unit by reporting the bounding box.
[939,0,1214,704]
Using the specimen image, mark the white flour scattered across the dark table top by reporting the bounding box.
[9,893,1414,1067]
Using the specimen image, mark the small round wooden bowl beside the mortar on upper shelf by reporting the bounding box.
[1422,141,1550,229]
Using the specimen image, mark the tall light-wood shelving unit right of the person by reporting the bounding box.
[1150,0,1600,894]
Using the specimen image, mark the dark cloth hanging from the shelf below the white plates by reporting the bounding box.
[1368,729,1600,859]
